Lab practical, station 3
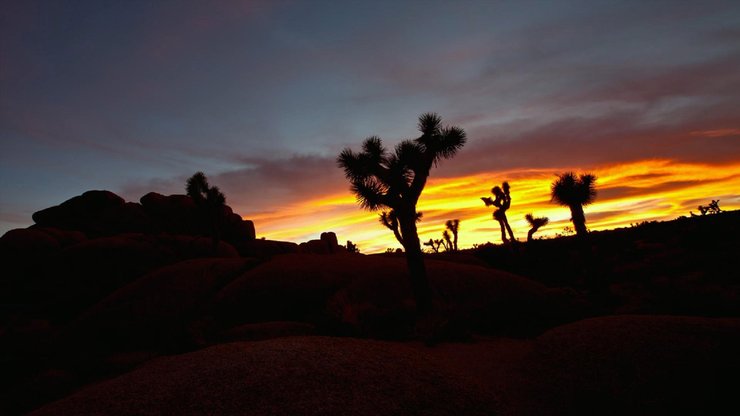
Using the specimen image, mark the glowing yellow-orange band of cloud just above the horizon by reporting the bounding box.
[249,160,740,253]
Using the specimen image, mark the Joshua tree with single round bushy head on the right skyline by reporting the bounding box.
[550,172,596,236]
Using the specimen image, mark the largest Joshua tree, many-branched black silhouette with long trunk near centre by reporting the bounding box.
[337,113,466,314]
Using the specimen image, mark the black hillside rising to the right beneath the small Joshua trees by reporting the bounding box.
[466,211,740,316]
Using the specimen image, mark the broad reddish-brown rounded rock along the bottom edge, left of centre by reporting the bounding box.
[31,337,496,416]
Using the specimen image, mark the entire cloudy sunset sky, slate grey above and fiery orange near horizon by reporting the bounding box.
[0,0,740,252]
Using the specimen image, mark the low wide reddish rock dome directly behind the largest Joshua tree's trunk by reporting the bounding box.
[215,254,585,338]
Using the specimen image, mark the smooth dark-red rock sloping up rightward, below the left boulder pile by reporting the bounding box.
[60,258,256,351]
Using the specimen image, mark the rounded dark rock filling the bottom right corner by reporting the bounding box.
[512,315,740,415]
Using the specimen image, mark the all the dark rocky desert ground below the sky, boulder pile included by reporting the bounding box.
[0,191,740,415]
